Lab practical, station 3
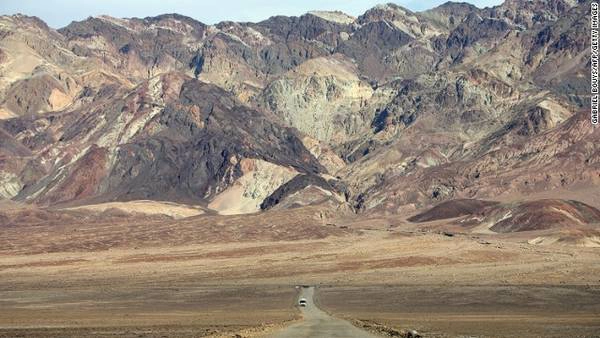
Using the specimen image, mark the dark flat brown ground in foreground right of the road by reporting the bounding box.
[319,285,600,338]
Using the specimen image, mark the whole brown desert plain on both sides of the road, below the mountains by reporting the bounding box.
[0,208,600,337]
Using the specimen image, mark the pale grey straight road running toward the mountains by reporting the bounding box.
[271,287,377,338]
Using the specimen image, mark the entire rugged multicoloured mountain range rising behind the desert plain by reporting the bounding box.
[0,0,600,219]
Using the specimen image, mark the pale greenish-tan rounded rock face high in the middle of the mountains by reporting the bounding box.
[262,55,373,144]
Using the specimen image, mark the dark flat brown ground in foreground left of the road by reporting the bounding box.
[0,280,297,337]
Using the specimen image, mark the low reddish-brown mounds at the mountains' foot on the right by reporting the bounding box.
[409,199,600,247]
